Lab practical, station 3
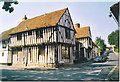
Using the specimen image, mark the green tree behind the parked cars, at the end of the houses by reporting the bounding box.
[95,37,106,54]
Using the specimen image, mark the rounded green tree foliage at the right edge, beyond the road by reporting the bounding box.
[108,30,119,48]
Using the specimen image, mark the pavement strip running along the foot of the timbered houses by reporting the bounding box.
[0,60,93,71]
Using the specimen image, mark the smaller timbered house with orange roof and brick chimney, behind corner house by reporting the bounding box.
[75,23,92,60]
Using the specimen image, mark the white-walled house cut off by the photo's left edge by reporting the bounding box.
[0,28,13,65]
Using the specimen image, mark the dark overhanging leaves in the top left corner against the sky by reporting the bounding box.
[2,0,18,13]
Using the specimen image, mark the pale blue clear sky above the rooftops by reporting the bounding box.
[0,1,118,45]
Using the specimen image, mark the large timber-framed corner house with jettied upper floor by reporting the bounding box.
[10,8,75,67]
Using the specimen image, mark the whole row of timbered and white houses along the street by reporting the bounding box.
[0,8,97,67]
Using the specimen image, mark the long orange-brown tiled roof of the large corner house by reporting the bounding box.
[10,8,68,34]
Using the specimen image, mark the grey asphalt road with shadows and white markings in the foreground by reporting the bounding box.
[0,53,118,81]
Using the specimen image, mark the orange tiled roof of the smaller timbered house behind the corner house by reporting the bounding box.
[75,26,90,38]
